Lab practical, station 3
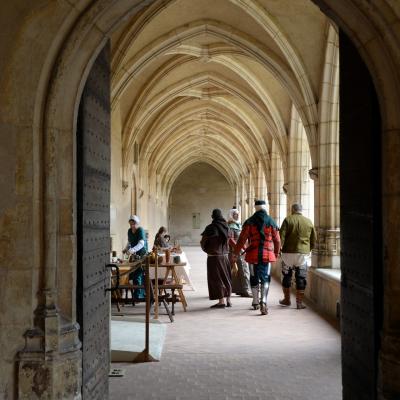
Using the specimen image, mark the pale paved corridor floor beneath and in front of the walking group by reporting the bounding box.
[110,247,341,400]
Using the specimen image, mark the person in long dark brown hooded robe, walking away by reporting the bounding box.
[200,208,232,308]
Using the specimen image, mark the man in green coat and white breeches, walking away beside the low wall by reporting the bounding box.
[279,203,316,310]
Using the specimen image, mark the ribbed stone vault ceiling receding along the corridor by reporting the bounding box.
[112,0,329,198]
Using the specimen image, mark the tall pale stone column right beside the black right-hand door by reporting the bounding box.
[310,26,340,268]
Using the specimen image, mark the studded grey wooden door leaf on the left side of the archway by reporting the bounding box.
[77,45,111,400]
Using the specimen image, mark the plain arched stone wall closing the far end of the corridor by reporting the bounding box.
[169,163,235,245]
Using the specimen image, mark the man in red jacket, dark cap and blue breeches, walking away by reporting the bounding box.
[234,200,281,315]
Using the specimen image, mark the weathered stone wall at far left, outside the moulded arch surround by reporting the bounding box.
[0,1,71,399]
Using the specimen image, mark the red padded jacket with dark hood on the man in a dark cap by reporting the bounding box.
[235,210,281,264]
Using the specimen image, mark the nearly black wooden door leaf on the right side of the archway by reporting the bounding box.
[340,32,383,400]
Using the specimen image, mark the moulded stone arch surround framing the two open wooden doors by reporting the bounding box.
[17,0,400,398]
